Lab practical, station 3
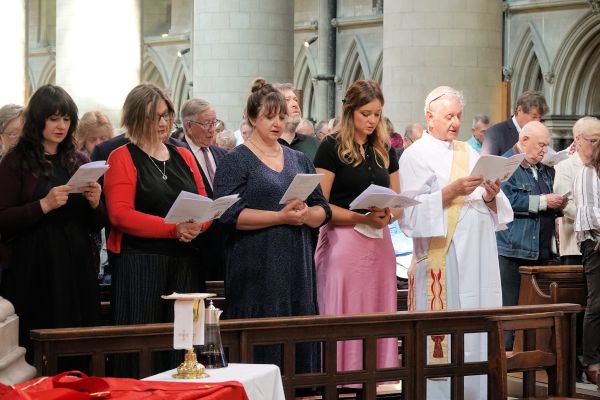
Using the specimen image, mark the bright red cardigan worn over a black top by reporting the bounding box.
[104,145,211,253]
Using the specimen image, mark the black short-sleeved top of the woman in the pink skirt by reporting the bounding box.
[315,135,398,209]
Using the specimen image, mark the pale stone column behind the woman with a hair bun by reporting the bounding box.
[192,0,294,130]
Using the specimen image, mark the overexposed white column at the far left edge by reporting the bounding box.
[0,0,27,107]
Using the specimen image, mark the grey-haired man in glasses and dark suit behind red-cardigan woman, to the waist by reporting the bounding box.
[179,99,227,281]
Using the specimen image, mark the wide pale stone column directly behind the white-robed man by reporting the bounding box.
[383,0,502,139]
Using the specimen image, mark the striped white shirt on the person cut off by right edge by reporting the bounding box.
[573,166,600,248]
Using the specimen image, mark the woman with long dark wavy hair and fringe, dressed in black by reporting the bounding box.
[0,85,106,362]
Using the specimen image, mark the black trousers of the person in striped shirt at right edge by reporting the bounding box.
[581,240,600,365]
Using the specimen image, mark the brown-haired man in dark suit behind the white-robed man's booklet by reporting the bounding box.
[481,90,548,156]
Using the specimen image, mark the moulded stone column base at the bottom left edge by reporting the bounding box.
[0,297,36,385]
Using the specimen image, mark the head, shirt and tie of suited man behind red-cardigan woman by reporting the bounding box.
[179,99,227,198]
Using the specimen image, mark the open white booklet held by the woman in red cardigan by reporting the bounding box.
[165,190,240,224]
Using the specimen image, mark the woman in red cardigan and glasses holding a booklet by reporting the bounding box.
[104,84,210,334]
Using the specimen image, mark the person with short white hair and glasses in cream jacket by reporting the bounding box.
[554,117,600,265]
